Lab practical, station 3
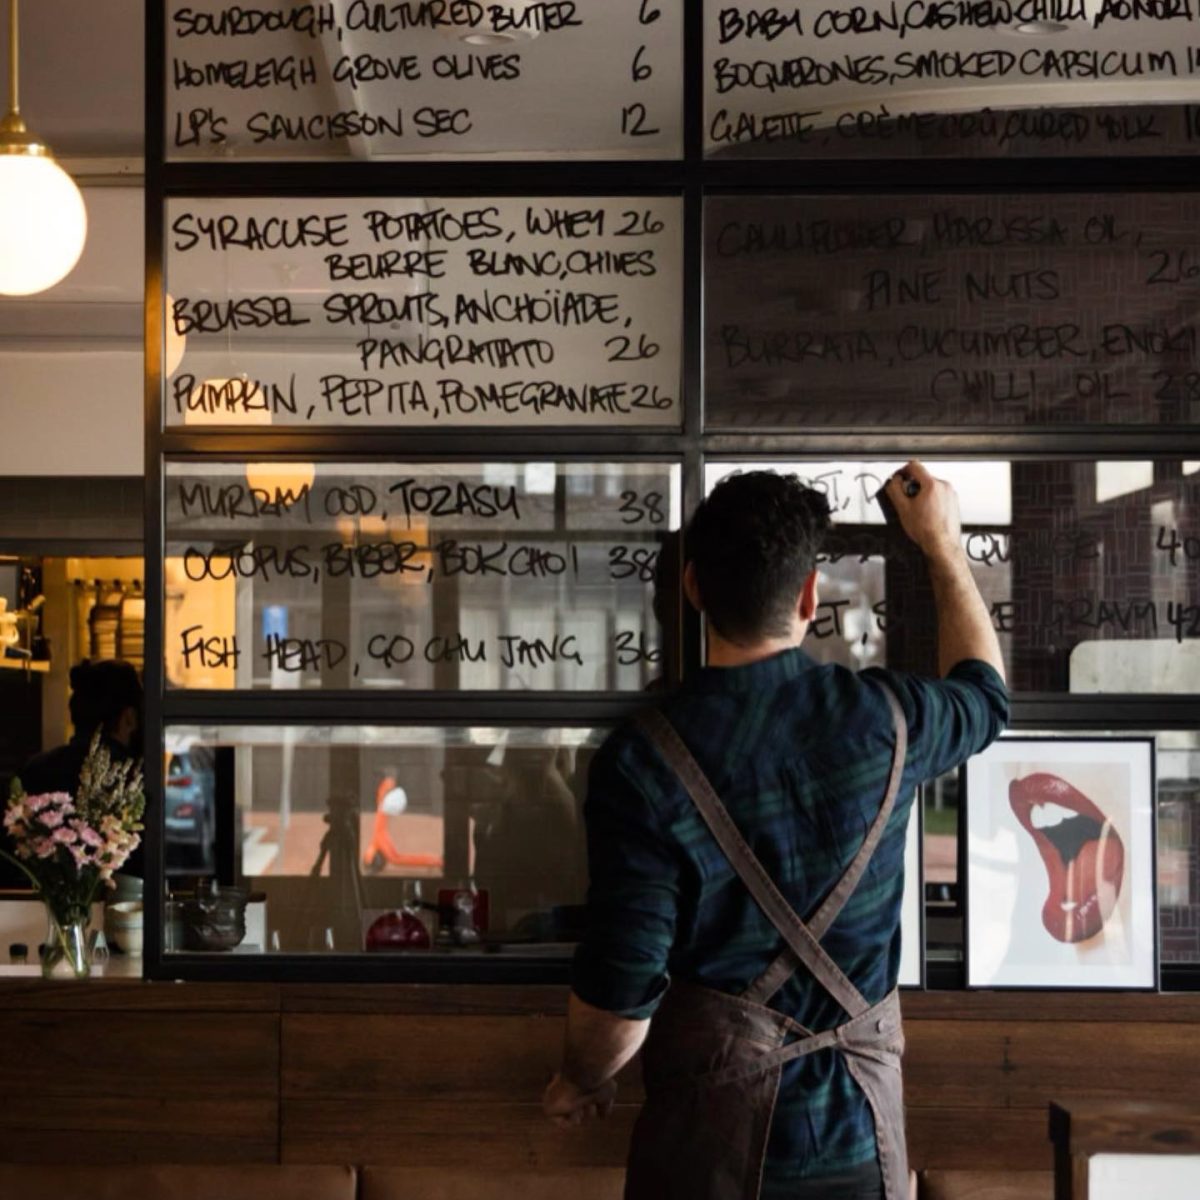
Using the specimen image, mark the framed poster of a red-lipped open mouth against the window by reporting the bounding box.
[966,738,1158,988]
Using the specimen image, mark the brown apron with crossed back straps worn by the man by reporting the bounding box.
[625,691,908,1200]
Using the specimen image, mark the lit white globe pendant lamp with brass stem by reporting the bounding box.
[0,0,88,296]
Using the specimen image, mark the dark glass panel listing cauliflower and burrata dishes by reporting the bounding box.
[704,193,1200,430]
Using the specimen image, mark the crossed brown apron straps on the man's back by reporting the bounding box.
[637,686,908,1018]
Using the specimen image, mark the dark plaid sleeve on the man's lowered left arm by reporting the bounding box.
[571,743,679,1020]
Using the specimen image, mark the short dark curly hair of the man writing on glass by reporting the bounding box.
[684,470,829,644]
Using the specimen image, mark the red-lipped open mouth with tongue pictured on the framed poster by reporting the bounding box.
[1008,772,1124,942]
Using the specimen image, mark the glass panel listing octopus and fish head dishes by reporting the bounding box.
[166,462,680,691]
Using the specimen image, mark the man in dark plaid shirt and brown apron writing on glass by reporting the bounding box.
[544,462,1008,1200]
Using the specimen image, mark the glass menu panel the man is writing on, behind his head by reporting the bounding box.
[707,460,1200,694]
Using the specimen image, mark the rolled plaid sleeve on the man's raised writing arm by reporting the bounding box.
[864,659,1008,779]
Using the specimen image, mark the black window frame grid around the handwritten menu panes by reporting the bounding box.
[144,0,1200,991]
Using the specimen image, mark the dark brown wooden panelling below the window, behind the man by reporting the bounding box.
[0,978,1200,1170]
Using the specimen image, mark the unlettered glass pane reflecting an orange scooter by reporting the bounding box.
[164,725,606,955]
